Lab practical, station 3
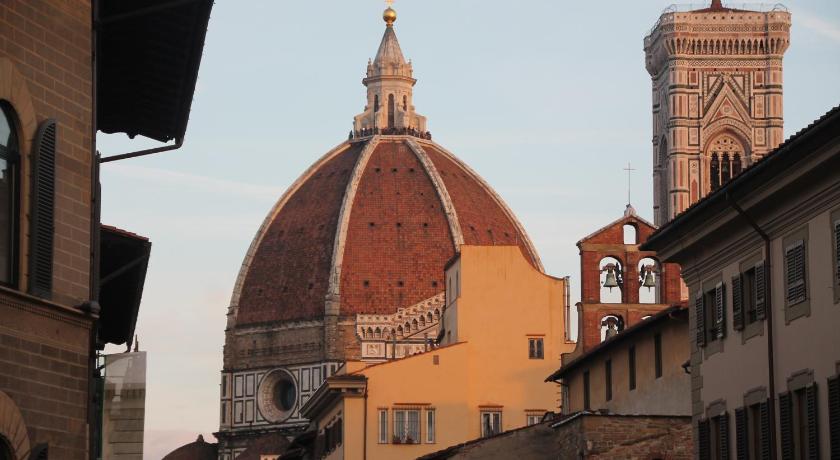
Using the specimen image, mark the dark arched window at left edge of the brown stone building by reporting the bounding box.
[0,101,20,285]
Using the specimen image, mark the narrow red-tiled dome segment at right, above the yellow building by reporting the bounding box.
[421,142,543,271]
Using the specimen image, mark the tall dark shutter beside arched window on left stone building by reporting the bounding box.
[29,119,57,299]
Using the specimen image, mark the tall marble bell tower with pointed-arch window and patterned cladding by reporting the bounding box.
[644,0,791,225]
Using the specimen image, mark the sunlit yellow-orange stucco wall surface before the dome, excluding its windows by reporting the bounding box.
[316,246,573,459]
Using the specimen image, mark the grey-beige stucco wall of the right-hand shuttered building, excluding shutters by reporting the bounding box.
[683,145,840,458]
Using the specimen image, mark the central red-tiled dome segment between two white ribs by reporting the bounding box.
[340,138,454,316]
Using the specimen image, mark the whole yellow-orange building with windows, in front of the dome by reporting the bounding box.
[302,246,574,459]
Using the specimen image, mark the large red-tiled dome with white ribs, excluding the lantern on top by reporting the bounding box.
[231,136,542,327]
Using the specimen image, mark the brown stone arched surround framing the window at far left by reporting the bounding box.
[0,57,38,292]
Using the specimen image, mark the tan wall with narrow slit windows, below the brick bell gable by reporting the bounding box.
[564,320,691,415]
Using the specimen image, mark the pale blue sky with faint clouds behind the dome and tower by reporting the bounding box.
[93,0,840,459]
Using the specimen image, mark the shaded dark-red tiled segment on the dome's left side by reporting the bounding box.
[236,144,364,326]
